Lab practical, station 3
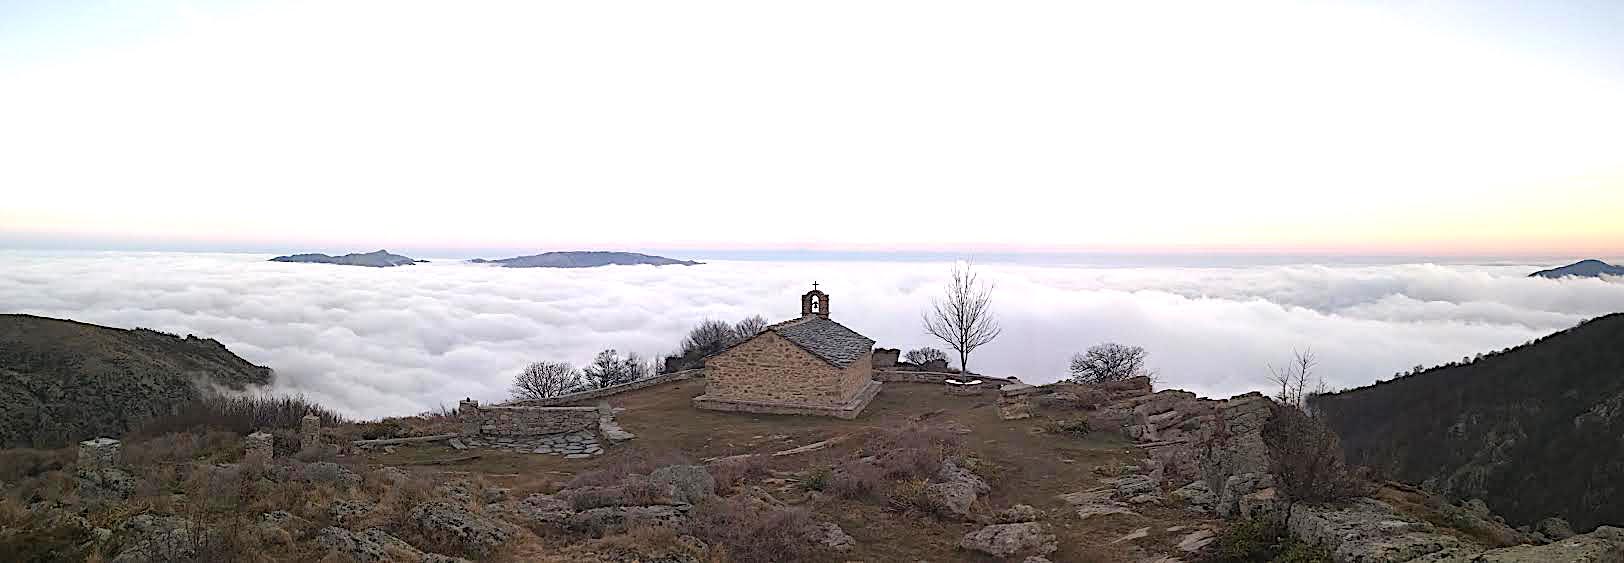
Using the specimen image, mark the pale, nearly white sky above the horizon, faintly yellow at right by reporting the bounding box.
[0,0,1624,256]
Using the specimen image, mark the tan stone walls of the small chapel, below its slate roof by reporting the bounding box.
[705,333,874,407]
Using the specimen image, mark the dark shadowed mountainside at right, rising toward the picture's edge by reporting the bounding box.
[1315,313,1624,529]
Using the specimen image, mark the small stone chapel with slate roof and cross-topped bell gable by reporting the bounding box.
[693,284,880,419]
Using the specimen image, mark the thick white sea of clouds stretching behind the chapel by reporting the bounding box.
[0,251,1624,417]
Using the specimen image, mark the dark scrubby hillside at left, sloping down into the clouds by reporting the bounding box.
[0,315,271,448]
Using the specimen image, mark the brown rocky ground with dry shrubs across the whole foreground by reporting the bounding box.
[0,380,1624,563]
